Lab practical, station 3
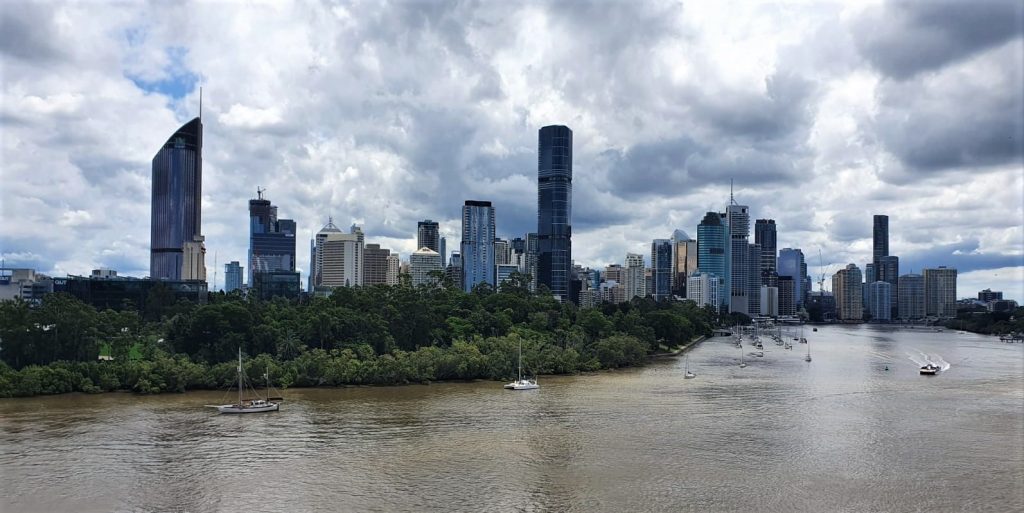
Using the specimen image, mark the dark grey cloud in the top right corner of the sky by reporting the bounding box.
[853,0,1024,80]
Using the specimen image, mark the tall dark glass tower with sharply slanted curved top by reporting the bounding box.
[150,118,205,280]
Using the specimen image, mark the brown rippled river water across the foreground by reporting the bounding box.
[0,326,1024,513]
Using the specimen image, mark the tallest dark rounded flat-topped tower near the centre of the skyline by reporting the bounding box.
[537,125,572,301]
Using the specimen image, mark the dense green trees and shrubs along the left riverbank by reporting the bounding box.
[0,277,718,396]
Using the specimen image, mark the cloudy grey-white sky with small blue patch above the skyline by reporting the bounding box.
[0,0,1024,300]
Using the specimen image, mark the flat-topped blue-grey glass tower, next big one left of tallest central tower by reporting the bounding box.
[460,200,495,292]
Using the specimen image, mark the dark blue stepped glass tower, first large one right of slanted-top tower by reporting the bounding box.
[249,189,298,285]
